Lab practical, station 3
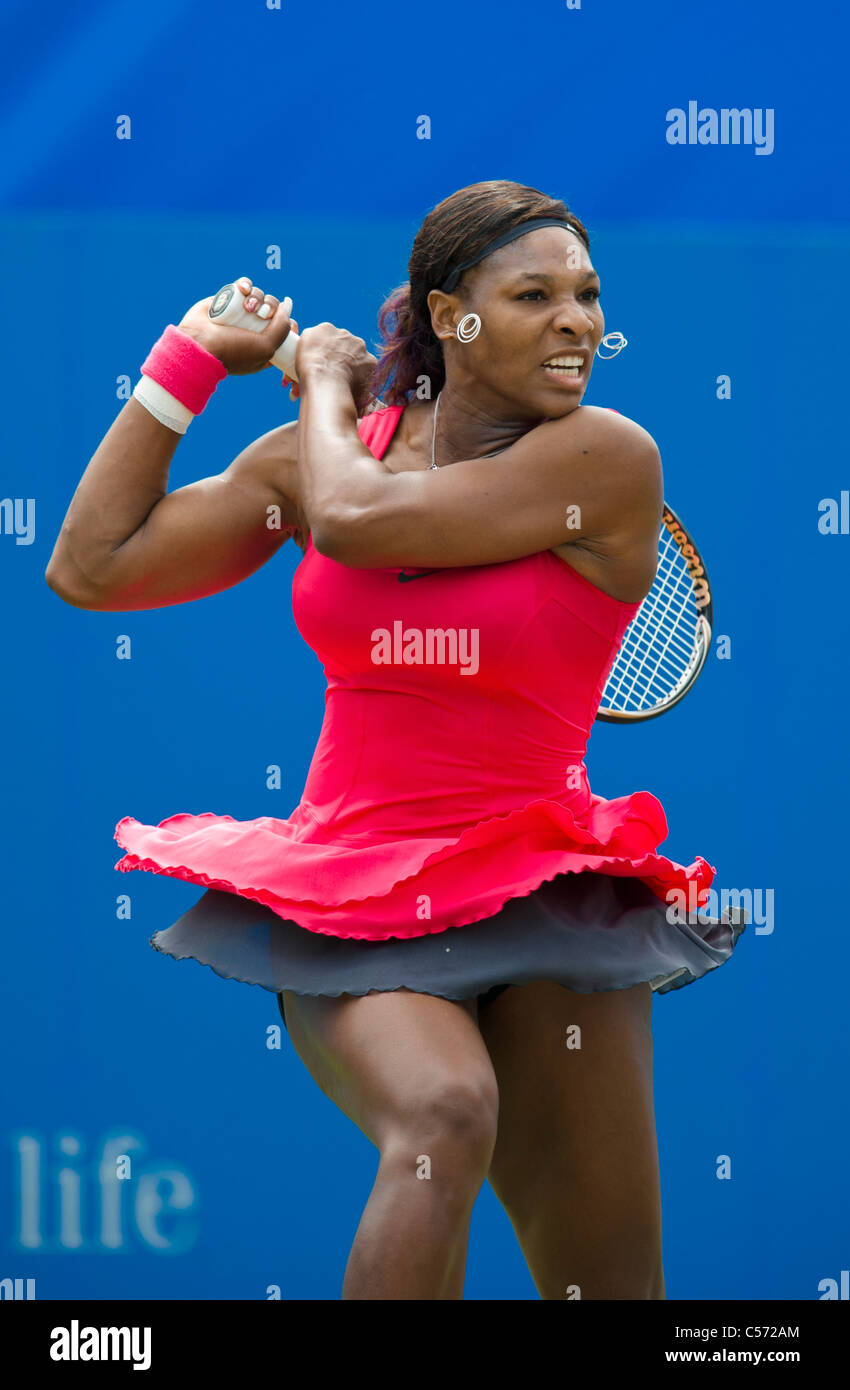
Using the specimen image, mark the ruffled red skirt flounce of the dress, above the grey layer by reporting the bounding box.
[115,791,715,941]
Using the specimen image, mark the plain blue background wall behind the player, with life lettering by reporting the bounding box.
[0,0,850,1300]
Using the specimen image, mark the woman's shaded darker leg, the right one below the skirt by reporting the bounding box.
[478,981,664,1300]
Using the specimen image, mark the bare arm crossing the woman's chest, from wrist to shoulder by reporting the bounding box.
[299,371,664,569]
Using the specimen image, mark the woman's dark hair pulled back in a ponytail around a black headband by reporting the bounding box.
[371,179,590,406]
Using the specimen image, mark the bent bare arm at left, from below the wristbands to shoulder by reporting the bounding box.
[44,398,304,612]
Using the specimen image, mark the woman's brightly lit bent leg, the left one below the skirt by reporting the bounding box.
[283,990,499,1300]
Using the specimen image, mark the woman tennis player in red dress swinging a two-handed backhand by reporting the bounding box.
[47,179,739,1300]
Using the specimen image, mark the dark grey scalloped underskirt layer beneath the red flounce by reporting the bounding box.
[150,870,746,1023]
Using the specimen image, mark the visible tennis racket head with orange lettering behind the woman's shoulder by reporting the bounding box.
[596,502,714,724]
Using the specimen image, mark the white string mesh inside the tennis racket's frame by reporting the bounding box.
[603,527,701,712]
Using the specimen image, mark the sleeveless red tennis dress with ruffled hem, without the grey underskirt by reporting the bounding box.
[115,406,714,941]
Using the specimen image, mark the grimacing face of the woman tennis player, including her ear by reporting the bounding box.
[429,227,606,418]
